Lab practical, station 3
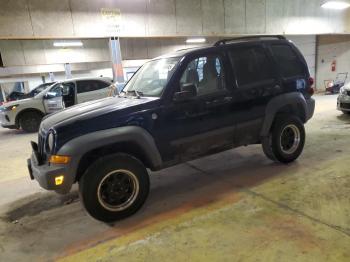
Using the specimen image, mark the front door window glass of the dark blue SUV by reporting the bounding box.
[180,55,225,96]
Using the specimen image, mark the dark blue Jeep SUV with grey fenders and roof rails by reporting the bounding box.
[28,36,315,222]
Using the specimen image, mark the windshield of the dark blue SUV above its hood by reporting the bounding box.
[122,57,180,97]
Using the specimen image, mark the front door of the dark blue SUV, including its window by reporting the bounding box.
[154,53,235,162]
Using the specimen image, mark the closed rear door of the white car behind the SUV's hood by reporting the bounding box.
[77,80,110,104]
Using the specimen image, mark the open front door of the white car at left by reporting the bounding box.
[43,84,64,114]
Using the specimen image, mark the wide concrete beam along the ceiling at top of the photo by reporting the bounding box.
[0,0,350,38]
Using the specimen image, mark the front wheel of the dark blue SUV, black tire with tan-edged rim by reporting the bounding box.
[79,153,150,223]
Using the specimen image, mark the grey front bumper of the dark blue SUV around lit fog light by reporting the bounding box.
[27,142,73,194]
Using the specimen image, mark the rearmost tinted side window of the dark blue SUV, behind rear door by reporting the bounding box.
[271,45,305,78]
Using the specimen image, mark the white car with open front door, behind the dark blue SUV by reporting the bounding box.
[0,77,112,132]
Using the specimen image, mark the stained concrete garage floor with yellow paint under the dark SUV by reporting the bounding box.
[0,96,350,261]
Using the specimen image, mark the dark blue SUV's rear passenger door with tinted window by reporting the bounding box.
[228,44,281,146]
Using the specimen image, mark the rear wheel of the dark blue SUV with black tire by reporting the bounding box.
[262,115,305,164]
